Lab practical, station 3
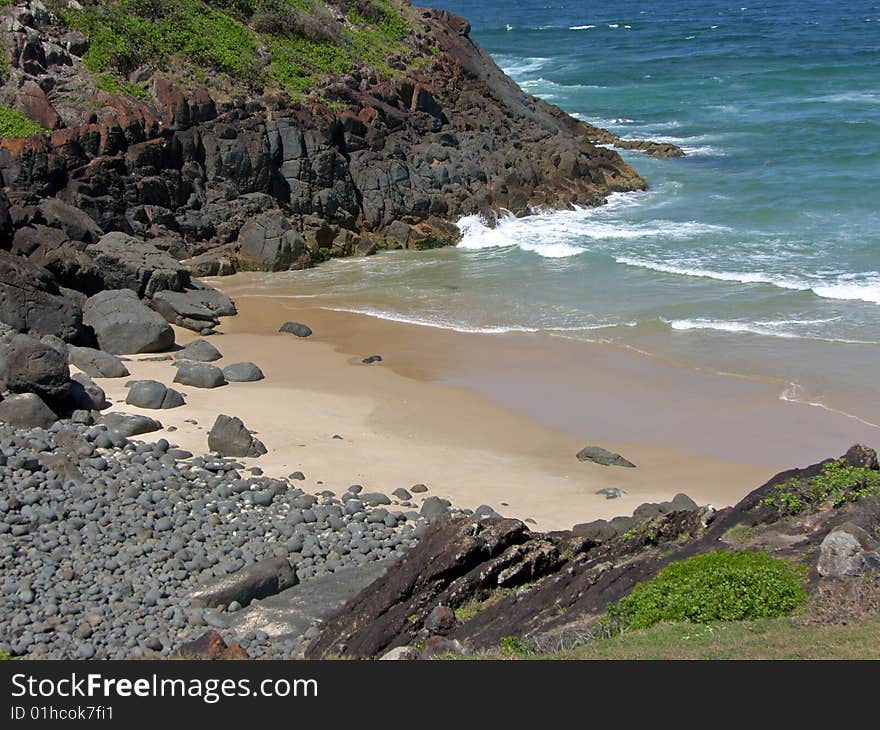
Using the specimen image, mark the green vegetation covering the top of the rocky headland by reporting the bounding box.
[57,0,410,97]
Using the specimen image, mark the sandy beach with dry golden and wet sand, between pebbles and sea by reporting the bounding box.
[84,277,870,529]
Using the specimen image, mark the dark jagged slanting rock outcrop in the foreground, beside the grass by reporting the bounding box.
[306,446,880,658]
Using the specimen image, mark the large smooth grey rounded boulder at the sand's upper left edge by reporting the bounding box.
[83,289,174,355]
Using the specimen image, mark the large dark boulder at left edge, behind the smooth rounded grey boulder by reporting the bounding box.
[0,250,90,344]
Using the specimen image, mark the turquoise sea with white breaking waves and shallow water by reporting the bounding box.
[248,0,880,423]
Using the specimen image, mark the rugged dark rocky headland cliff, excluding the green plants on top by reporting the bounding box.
[0,1,660,275]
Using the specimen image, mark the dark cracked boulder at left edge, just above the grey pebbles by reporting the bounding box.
[0,335,70,403]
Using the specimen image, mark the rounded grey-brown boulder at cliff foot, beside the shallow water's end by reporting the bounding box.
[236,210,311,271]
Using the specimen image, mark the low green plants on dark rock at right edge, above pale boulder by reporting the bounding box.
[764,459,880,514]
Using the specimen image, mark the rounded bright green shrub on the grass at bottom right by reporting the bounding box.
[607,551,807,631]
